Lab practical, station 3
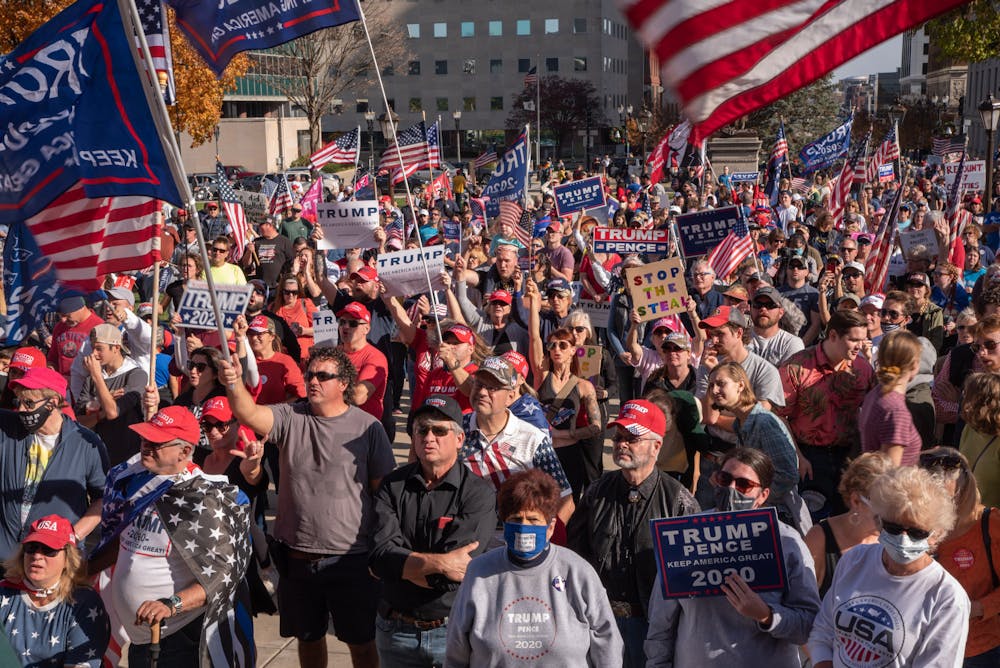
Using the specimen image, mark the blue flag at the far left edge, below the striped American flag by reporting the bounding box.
[3,221,60,346]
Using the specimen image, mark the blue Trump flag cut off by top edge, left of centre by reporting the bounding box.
[167,0,361,76]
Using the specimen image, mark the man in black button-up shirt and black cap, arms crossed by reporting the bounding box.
[369,394,497,667]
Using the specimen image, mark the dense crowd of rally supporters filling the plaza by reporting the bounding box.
[0,154,1000,668]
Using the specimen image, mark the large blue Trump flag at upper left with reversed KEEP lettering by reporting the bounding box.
[0,0,184,225]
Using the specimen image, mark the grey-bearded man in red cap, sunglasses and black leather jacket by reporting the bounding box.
[566,399,701,668]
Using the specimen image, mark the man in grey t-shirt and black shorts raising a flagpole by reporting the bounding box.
[220,347,395,666]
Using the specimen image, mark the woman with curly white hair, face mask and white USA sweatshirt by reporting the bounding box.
[809,466,971,668]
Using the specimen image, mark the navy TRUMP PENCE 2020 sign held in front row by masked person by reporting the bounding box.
[649,508,787,598]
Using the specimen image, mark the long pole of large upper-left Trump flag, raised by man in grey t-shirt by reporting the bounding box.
[118,0,232,363]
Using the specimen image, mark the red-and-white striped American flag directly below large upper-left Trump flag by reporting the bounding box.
[27,182,160,291]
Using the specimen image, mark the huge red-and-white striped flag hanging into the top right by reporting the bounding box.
[618,0,963,137]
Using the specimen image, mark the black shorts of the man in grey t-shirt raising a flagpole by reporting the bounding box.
[278,554,380,645]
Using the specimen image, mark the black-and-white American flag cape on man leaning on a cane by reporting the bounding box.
[92,454,257,668]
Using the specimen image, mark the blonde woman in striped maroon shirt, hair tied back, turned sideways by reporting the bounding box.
[858,329,922,466]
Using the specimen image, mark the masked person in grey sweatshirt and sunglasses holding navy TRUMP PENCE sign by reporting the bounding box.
[645,447,820,668]
